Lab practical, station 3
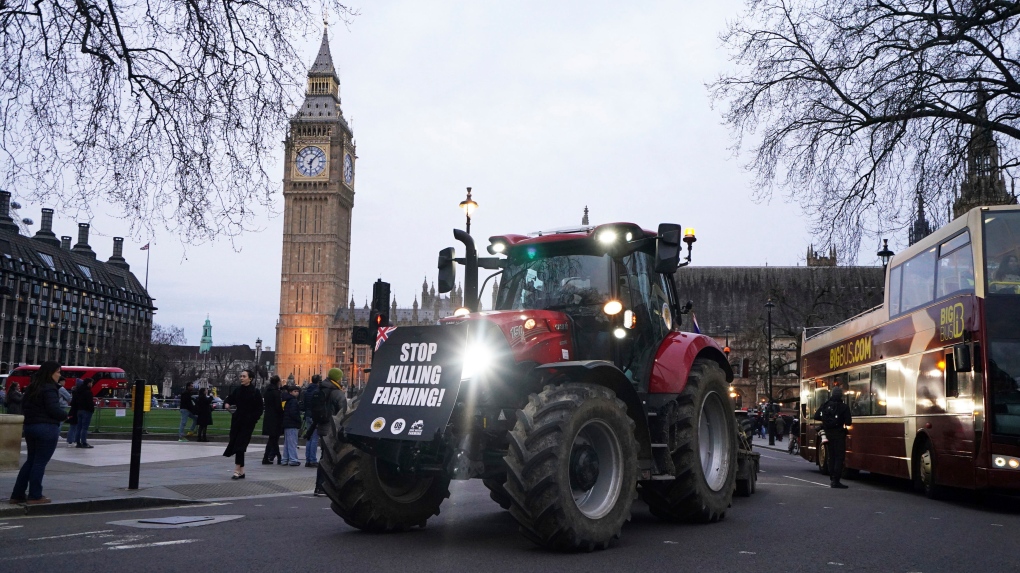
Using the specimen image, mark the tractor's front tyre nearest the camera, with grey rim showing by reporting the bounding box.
[504,383,638,551]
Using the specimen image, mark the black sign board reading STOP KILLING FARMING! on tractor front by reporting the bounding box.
[345,324,467,440]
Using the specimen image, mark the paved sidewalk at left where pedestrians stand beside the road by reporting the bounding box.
[0,439,315,517]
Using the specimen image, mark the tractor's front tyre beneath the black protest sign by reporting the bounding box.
[319,409,450,533]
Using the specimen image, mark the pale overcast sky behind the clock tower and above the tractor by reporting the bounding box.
[15,0,871,348]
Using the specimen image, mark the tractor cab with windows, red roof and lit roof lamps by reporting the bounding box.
[489,223,694,390]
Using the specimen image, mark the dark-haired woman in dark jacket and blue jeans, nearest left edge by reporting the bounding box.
[8,361,67,505]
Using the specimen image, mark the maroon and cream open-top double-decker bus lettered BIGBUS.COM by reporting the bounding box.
[801,206,1020,498]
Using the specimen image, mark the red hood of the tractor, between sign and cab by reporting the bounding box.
[440,310,574,364]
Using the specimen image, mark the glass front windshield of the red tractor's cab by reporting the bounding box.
[496,252,613,310]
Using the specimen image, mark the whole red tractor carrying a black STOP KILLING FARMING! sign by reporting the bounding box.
[320,223,753,551]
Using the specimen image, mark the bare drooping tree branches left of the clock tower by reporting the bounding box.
[0,0,354,241]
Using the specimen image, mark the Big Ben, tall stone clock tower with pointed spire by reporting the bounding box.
[276,31,357,383]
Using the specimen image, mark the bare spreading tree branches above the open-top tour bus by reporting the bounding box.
[709,0,1020,260]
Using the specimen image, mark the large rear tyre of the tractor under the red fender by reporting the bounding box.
[641,359,737,523]
